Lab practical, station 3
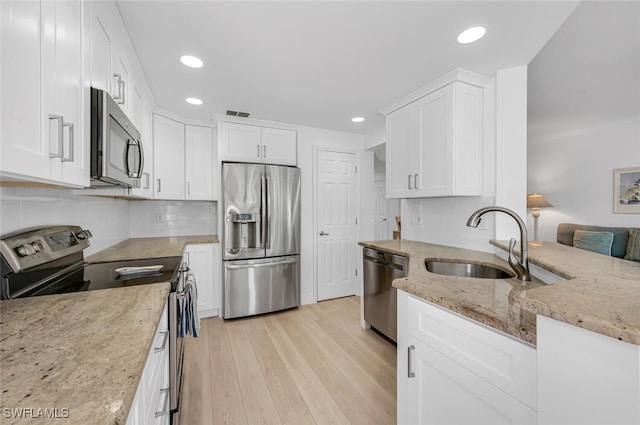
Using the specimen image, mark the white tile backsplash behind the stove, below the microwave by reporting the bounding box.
[0,187,217,255]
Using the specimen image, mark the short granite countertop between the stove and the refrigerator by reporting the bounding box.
[85,235,220,263]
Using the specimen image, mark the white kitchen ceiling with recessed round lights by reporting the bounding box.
[117,0,577,134]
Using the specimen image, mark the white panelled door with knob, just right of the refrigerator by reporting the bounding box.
[315,151,357,301]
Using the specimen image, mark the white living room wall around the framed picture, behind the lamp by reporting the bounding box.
[527,117,640,241]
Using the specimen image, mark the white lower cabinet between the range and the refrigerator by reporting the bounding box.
[183,243,222,318]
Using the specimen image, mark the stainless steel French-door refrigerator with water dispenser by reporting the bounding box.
[222,162,300,319]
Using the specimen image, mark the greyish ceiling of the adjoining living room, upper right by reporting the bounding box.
[528,1,640,143]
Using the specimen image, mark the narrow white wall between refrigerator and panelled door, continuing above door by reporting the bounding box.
[298,126,362,304]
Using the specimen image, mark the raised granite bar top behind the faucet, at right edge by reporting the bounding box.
[491,241,640,345]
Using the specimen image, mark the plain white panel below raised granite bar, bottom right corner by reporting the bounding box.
[537,316,640,425]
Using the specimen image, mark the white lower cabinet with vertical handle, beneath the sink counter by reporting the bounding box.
[397,291,537,425]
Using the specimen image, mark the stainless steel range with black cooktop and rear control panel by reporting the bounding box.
[0,226,192,425]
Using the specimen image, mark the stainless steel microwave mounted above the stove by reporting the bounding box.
[91,87,144,187]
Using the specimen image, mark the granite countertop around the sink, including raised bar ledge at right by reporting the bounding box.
[360,240,640,345]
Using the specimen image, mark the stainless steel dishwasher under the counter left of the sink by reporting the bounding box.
[362,248,409,342]
